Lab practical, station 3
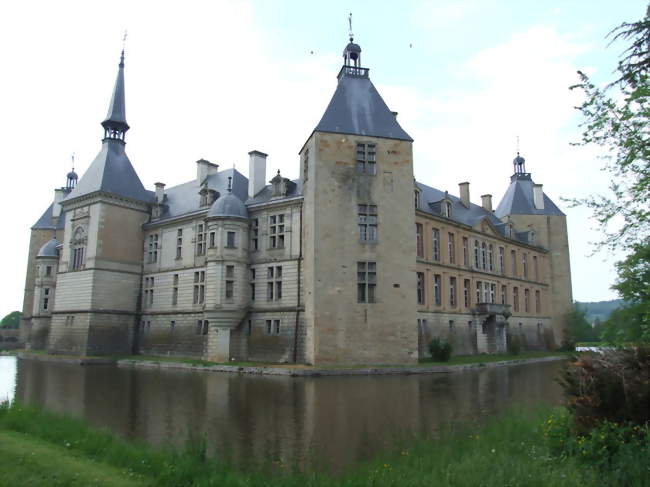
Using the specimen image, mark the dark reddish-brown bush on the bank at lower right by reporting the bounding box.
[560,347,650,434]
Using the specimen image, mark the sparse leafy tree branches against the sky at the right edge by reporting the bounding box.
[569,5,650,250]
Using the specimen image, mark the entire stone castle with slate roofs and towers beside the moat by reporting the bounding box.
[21,38,572,365]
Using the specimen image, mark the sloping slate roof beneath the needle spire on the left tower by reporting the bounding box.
[64,139,153,202]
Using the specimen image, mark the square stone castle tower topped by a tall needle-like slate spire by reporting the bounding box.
[48,51,153,355]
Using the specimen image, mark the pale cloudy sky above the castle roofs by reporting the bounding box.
[0,0,645,317]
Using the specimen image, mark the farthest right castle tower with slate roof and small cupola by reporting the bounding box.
[495,152,573,345]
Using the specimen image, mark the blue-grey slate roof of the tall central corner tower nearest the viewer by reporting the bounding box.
[314,70,413,142]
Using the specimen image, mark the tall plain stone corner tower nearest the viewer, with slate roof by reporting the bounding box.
[300,31,418,365]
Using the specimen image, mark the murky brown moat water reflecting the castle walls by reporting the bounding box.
[0,357,561,467]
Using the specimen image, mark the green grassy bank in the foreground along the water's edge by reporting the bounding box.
[0,405,650,487]
